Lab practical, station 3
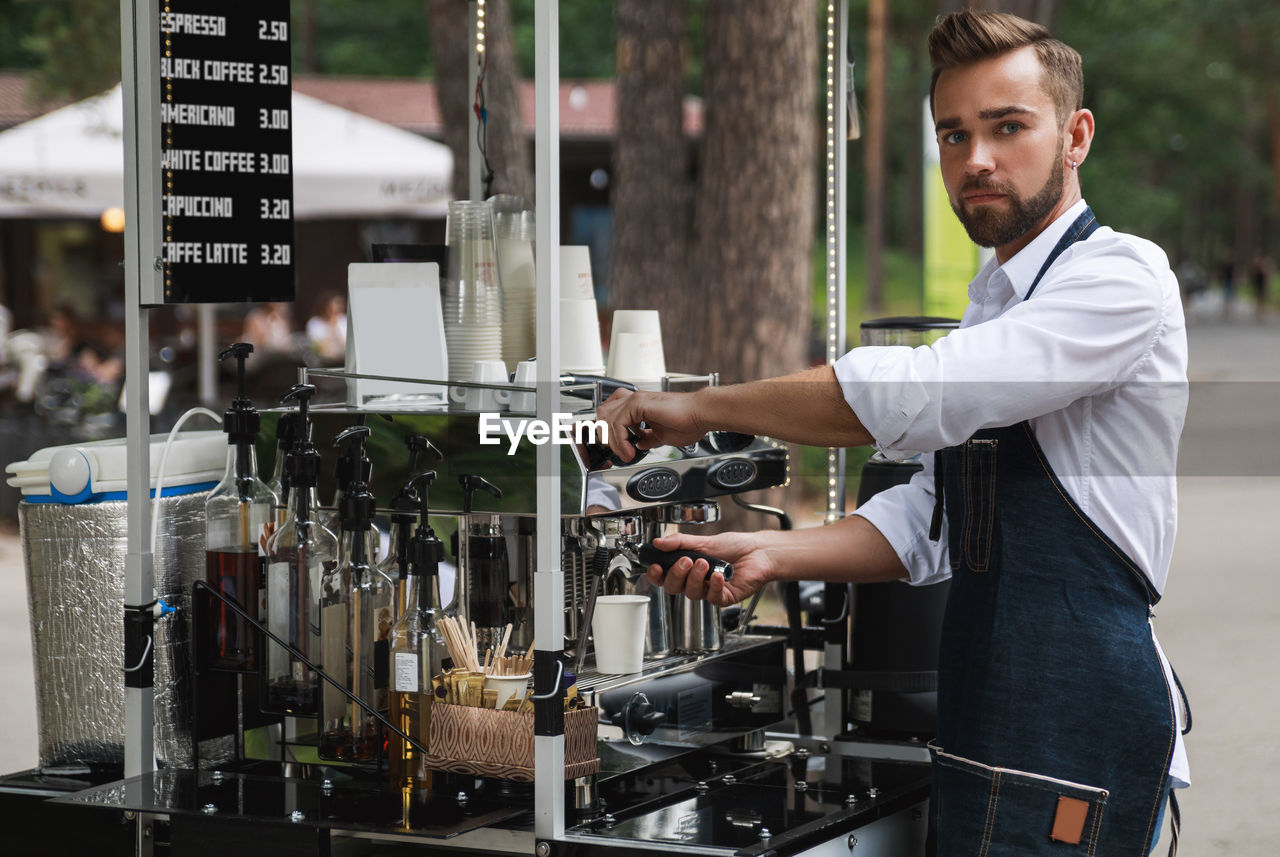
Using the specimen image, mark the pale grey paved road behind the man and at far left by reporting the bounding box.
[0,321,1280,857]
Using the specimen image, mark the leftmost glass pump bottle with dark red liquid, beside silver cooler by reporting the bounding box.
[204,343,275,672]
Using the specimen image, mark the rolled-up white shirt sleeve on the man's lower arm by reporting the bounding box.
[851,455,951,586]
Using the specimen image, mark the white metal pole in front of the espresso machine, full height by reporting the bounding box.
[534,0,564,839]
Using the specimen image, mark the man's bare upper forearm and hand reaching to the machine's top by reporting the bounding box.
[596,366,872,459]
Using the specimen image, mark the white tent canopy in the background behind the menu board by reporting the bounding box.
[0,86,453,219]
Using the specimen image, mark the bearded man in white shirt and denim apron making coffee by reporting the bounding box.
[599,12,1189,857]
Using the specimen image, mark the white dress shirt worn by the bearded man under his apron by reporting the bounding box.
[835,200,1189,784]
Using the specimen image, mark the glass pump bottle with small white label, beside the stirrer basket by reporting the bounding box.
[387,471,448,788]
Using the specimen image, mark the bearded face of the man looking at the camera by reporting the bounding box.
[933,47,1065,258]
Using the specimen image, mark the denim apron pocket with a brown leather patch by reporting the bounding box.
[929,746,1107,857]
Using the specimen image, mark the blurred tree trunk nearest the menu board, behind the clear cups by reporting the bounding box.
[426,0,534,203]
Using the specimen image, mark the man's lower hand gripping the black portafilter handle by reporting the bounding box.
[646,532,776,608]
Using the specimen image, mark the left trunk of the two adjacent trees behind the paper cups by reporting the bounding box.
[609,0,692,318]
